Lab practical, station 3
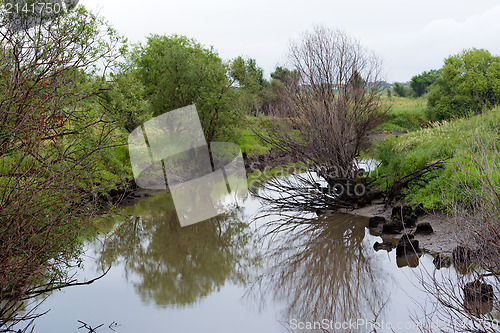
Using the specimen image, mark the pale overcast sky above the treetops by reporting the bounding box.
[80,0,500,82]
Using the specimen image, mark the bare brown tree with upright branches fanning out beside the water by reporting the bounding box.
[257,27,387,210]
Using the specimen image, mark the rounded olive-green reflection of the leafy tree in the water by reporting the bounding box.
[100,192,251,307]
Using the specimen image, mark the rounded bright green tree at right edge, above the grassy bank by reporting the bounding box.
[428,48,500,120]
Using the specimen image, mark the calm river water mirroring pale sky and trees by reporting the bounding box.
[31,187,452,333]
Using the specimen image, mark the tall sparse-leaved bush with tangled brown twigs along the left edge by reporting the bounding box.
[0,7,125,331]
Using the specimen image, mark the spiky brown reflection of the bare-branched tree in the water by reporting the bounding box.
[247,214,389,328]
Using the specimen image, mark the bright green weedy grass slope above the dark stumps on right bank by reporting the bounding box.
[375,107,500,210]
